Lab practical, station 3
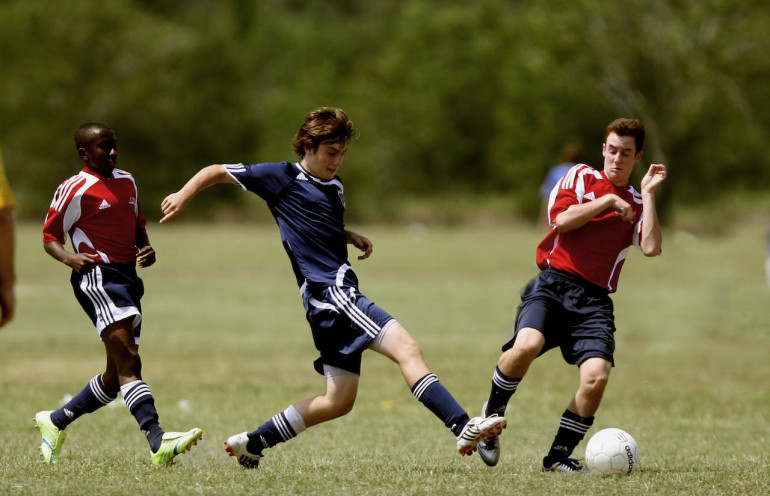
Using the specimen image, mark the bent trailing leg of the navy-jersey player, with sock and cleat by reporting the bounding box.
[225,365,360,468]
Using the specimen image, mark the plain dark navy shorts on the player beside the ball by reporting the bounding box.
[503,268,615,365]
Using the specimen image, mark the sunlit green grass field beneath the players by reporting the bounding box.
[0,224,770,496]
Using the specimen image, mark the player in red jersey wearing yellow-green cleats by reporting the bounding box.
[35,123,203,466]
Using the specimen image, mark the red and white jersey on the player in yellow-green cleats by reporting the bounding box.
[43,168,147,263]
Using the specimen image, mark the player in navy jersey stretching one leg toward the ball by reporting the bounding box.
[161,107,506,468]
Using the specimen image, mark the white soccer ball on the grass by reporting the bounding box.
[586,428,639,477]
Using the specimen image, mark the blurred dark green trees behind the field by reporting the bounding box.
[0,0,770,224]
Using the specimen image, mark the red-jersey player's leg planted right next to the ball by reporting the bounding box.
[543,357,612,472]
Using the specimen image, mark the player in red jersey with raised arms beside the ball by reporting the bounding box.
[478,119,666,472]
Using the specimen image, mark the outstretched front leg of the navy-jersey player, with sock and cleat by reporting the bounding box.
[370,321,506,455]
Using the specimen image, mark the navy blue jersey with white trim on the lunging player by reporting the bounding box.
[224,162,357,291]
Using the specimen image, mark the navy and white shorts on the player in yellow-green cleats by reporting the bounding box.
[70,263,144,345]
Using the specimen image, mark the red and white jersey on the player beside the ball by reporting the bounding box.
[536,164,643,293]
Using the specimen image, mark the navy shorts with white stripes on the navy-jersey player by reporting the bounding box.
[302,286,395,375]
